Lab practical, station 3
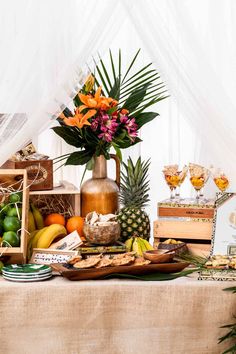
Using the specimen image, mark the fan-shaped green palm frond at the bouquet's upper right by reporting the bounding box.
[95,49,168,115]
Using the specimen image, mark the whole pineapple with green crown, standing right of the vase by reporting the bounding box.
[118,157,150,241]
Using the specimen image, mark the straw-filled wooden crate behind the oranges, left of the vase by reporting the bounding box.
[30,181,80,218]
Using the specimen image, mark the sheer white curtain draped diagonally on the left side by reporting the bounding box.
[0,0,122,164]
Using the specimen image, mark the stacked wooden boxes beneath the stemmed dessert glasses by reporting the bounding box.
[154,199,215,255]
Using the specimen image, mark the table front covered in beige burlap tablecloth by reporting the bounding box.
[0,276,236,354]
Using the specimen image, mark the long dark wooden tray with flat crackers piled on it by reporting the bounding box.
[53,252,189,280]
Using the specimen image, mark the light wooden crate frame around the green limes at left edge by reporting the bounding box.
[0,169,29,263]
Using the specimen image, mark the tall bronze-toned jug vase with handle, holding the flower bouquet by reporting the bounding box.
[81,155,120,216]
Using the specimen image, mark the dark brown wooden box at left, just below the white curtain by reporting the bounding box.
[1,160,53,191]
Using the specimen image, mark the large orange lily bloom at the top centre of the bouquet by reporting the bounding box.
[78,86,118,112]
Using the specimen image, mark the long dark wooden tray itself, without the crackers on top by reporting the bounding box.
[51,262,189,280]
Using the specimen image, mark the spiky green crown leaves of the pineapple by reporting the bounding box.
[120,157,150,209]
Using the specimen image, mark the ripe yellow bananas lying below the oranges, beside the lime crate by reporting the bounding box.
[28,224,67,259]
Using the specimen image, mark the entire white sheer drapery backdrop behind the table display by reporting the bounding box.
[0,0,236,218]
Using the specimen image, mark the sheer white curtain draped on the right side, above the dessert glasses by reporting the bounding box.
[125,0,236,188]
